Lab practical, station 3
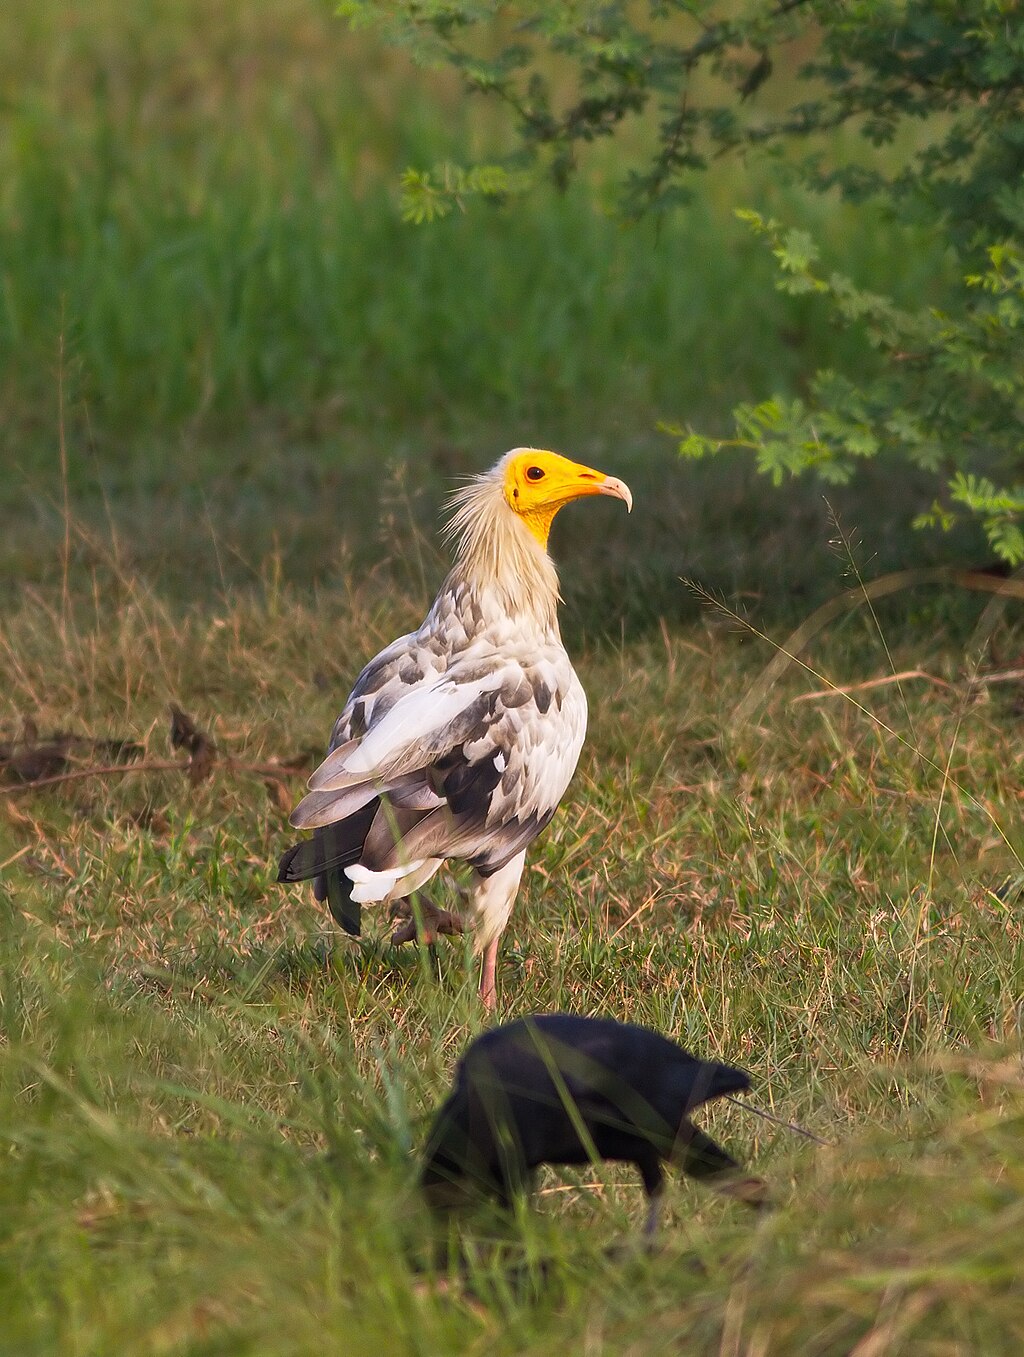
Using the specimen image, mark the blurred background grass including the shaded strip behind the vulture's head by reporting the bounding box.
[0,0,963,623]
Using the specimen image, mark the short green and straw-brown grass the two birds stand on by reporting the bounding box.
[0,537,1024,1354]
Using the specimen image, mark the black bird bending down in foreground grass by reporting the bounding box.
[420,1014,768,1235]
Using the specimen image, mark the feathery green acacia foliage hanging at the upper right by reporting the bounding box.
[340,0,1024,565]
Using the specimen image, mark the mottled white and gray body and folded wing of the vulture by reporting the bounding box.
[292,626,586,871]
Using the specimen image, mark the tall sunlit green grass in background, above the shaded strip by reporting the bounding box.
[0,0,940,461]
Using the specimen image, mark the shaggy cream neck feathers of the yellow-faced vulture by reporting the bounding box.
[445,463,559,632]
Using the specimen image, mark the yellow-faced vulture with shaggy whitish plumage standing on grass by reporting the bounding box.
[278,448,632,1008]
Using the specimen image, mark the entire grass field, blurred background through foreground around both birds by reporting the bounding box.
[0,0,1024,1357]
